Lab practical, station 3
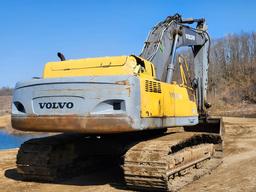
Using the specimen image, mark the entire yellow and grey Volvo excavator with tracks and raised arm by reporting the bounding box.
[12,14,223,191]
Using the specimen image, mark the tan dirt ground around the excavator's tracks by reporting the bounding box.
[0,117,256,192]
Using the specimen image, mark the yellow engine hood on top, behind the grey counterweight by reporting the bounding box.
[43,56,154,78]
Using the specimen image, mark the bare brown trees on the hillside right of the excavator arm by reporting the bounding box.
[209,32,256,103]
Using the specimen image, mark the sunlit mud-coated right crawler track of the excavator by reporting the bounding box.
[123,132,222,191]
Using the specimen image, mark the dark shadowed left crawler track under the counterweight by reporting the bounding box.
[16,134,124,181]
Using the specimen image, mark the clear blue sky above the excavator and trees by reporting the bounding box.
[0,0,256,87]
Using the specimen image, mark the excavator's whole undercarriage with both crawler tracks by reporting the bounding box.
[17,118,223,191]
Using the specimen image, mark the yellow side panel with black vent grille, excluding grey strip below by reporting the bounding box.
[140,78,198,117]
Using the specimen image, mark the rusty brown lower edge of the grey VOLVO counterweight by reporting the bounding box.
[12,115,136,134]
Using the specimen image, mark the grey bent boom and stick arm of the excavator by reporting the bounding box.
[140,14,210,115]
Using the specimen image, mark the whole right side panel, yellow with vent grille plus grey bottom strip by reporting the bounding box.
[140,78,198,128]
